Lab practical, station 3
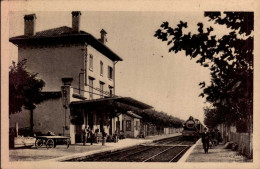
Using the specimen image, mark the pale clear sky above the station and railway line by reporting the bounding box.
[9,11,217,122]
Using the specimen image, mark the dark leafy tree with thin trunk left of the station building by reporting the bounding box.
[9,60,46,135]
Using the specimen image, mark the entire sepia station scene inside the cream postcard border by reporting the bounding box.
[1,0,257,168]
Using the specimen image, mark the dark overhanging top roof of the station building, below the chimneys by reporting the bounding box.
[9,26,123,61]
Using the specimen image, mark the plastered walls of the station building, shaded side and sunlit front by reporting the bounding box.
[10,42,117,143]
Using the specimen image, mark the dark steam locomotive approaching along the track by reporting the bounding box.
[182,116,204,139]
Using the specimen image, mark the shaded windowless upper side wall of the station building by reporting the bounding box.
[18,45,84,91]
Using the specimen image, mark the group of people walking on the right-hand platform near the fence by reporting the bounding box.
[201,128,222,154]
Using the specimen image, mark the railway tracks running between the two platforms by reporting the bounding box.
[67,136,195,162]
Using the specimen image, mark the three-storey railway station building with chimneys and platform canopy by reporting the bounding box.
[9,11,152,144]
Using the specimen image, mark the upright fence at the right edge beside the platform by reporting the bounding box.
[230,132,253,158]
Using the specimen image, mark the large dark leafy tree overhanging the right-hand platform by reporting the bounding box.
[154,12,254,131]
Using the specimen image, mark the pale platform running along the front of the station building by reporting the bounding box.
[9,133,181,162]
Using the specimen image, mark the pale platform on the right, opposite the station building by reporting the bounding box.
[179,139,252,162]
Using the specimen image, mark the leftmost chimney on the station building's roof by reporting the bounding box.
[24,14,37,36]
